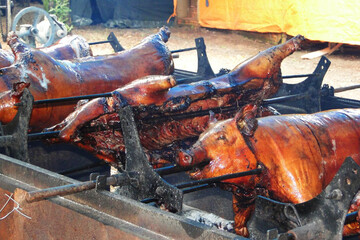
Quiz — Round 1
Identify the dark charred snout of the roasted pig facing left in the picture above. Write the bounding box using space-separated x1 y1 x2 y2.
177 147 207 167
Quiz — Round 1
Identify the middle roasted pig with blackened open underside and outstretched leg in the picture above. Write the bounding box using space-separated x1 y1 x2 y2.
47 36 303 165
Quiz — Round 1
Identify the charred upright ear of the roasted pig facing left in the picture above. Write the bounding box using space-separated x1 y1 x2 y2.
235 104 258 137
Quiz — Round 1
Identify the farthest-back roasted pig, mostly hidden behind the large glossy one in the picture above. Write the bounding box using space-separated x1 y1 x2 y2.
0 32 92 68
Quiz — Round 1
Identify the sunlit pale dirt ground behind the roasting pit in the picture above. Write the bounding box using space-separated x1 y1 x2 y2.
2 10 360 100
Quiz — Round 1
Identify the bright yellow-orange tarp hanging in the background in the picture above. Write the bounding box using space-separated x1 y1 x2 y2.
198 0 360 45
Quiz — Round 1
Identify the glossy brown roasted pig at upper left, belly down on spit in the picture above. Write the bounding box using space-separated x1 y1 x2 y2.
0 28 174 130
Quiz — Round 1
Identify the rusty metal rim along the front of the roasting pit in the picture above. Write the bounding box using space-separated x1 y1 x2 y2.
0 154 246 239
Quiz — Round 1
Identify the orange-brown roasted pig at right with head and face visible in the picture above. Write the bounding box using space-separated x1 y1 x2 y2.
178 106 360 235
